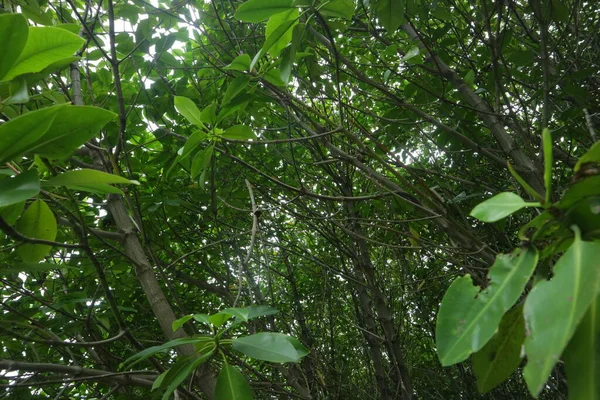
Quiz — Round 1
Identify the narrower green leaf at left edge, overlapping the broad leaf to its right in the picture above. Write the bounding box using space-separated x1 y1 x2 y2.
0 105 68 163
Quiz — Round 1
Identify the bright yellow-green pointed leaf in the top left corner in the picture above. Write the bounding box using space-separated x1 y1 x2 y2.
2 26 85 81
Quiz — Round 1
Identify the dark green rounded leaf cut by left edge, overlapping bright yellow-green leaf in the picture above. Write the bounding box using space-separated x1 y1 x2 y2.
0 14 28 81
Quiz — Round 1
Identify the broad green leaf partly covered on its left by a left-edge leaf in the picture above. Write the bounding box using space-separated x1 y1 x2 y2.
26 105 117 159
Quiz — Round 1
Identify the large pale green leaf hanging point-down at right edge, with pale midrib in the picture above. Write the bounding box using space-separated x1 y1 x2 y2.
523 228 600 396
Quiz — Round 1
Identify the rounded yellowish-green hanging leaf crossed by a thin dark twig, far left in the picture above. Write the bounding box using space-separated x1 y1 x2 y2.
17 200 57 263
